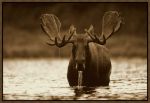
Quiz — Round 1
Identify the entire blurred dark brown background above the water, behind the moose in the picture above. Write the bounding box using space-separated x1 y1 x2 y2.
3 3 147 57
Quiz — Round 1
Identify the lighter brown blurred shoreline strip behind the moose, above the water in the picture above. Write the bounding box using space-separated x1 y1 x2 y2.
3 27 147 58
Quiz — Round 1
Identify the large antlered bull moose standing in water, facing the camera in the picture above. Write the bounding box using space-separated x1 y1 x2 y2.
41 11 122 87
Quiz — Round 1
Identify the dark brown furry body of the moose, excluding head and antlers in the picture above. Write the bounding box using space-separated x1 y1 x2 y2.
67 43 111 86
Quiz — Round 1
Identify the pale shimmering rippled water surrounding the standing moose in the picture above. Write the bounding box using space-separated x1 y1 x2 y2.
3 58 147 100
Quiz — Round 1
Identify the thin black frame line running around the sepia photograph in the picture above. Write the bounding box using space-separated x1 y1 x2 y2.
1 1 149 101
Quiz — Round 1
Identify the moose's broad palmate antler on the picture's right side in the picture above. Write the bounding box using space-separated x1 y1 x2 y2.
85 11 122 45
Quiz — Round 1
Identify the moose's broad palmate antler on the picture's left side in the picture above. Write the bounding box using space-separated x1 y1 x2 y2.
41 14 76 47
